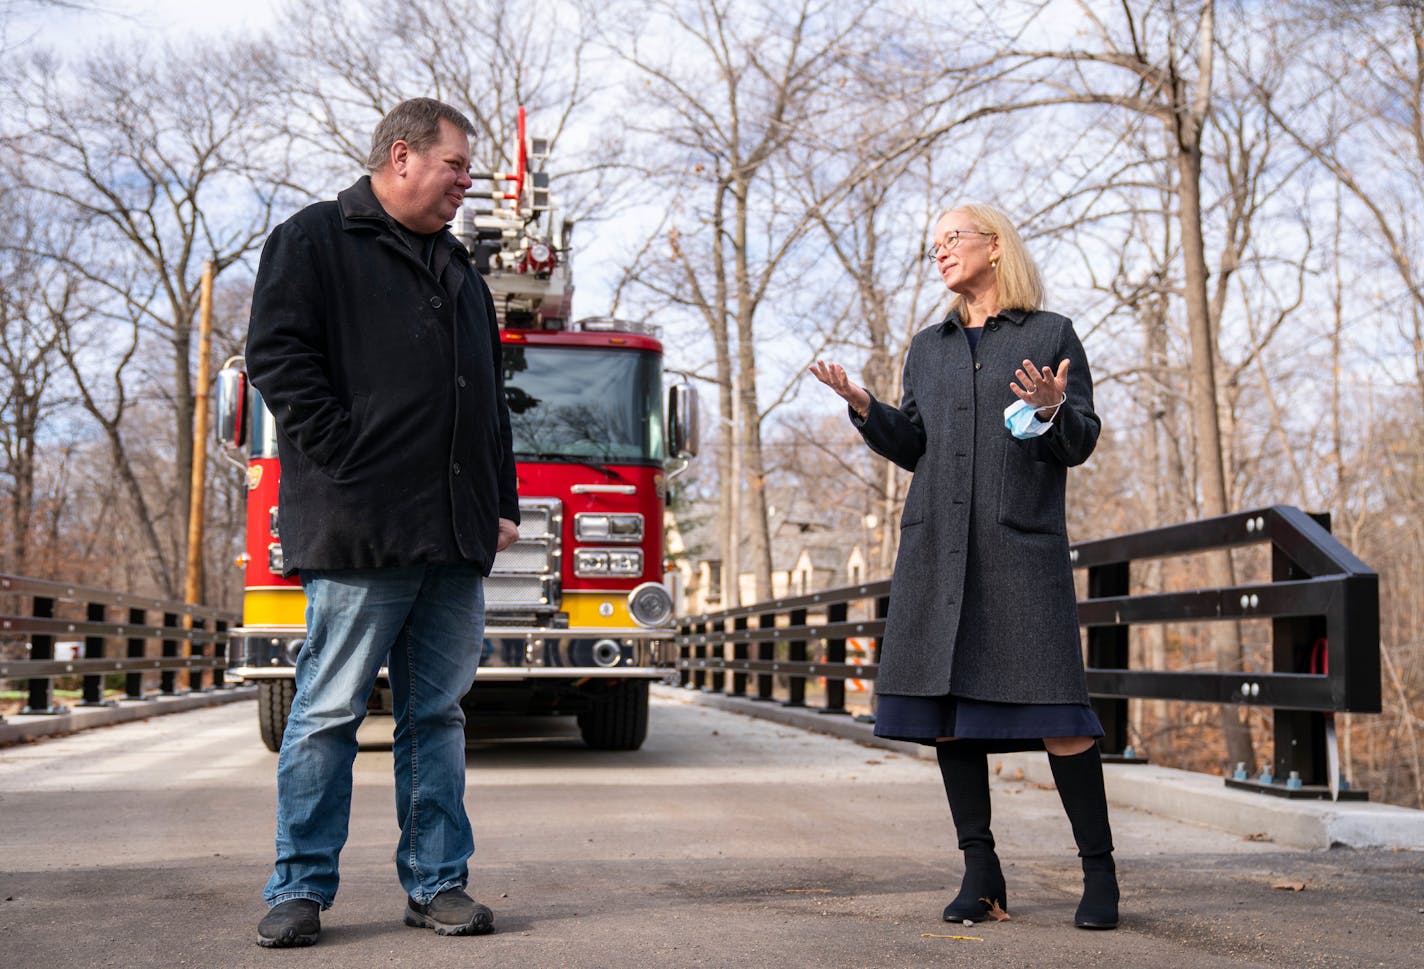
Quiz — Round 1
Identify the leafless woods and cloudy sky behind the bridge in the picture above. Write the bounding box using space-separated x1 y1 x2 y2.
0 0 1424 807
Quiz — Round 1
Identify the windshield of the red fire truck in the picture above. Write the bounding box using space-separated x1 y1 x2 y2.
504 343 664 463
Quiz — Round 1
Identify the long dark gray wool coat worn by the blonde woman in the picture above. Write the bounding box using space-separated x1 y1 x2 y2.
852 309 1101 704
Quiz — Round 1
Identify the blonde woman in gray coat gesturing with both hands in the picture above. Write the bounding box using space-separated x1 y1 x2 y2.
812 205 1118 929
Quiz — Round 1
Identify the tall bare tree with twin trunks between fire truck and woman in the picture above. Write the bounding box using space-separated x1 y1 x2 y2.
608 0 899 597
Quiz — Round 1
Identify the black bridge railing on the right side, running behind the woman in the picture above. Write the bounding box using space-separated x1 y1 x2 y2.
678 504 1380 797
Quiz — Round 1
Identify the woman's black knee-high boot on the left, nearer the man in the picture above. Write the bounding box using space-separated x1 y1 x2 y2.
936 741 1008 922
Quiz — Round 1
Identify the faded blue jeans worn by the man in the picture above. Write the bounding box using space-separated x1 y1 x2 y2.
262 566 484 909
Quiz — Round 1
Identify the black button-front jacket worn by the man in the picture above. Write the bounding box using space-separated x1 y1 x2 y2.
246 178 518 574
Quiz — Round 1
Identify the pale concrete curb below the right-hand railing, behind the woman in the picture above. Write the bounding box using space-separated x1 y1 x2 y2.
655 687 1424 851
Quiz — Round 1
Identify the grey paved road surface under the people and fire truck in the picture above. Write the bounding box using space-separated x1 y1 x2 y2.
0 695 1424 969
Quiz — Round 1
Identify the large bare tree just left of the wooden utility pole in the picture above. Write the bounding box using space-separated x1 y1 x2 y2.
4 44 290 594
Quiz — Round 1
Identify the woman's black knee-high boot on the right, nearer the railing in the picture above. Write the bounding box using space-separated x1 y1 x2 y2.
1048 744 1118 929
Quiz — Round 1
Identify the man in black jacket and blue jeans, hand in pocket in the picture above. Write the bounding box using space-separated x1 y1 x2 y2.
246 98 518 946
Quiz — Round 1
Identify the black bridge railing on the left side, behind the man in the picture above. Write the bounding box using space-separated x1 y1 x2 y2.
0 574 238 720
